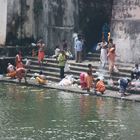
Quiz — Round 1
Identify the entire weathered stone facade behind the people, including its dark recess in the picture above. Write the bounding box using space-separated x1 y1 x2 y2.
0 0 140 62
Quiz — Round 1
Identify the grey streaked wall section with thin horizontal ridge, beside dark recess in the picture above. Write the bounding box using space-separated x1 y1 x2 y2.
40 0 78 53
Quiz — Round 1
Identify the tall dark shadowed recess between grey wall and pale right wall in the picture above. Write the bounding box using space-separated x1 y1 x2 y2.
79 0 113 51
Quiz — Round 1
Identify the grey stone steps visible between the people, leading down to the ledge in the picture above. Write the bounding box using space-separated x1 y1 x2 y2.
24 53 140 93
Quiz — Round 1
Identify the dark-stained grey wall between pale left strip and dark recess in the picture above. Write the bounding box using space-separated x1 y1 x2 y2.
7 0 78 52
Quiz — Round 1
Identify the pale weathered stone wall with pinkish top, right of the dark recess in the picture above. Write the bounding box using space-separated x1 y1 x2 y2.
111 0 140 63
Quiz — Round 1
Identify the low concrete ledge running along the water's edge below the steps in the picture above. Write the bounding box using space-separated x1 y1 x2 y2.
0 78 140 102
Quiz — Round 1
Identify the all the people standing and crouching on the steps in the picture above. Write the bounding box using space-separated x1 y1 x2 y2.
4 35 140 96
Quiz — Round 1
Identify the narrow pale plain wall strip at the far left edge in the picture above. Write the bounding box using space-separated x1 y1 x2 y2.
0 0 7 45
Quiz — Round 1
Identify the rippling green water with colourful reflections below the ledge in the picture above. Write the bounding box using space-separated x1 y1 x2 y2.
0 83 140 140
